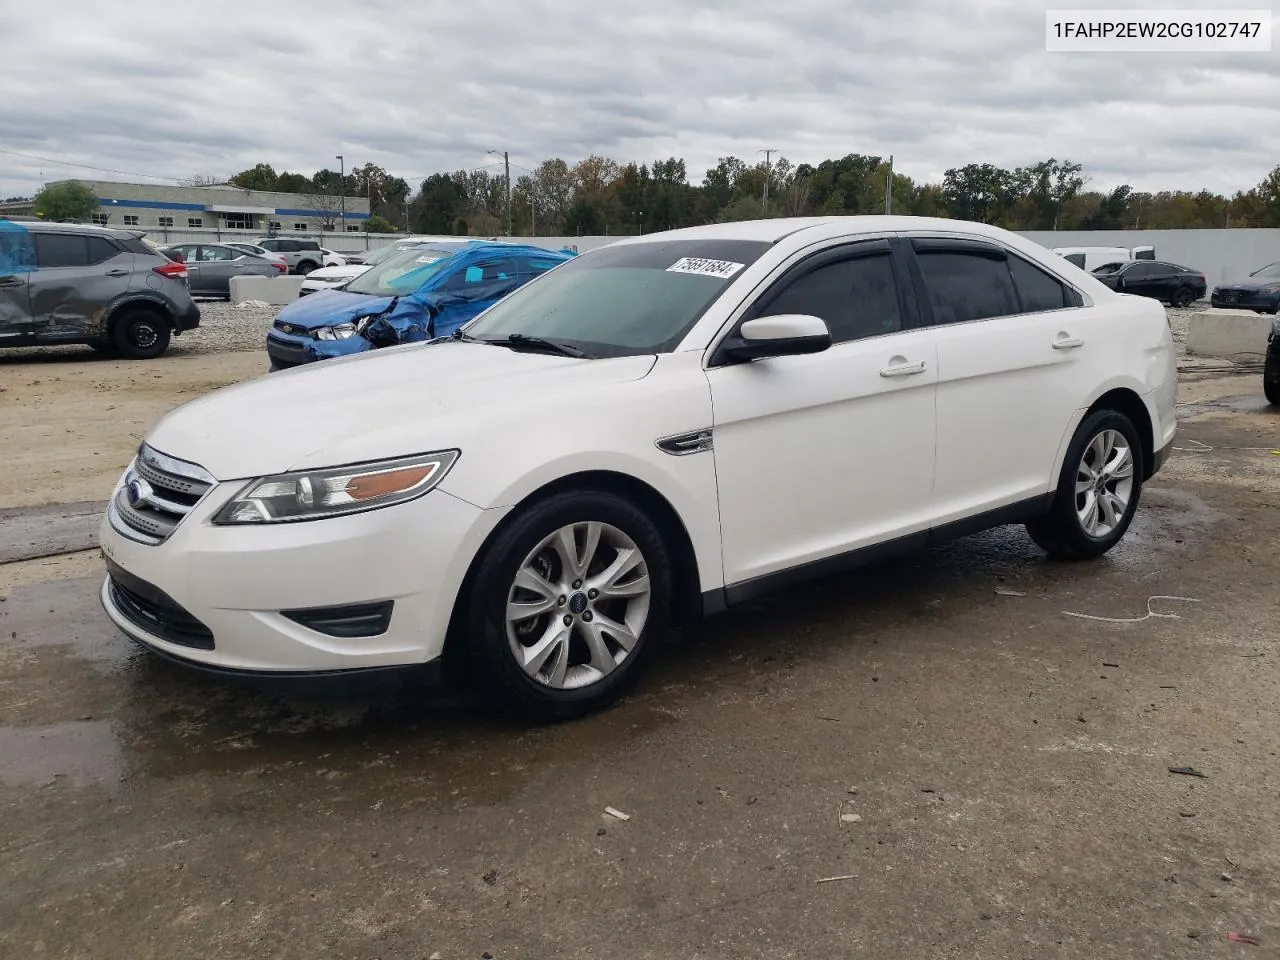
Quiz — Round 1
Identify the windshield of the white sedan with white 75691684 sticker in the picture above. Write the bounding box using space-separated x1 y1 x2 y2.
466 239 769 357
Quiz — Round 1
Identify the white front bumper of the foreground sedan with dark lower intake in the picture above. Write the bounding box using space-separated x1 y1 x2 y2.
99 481 504 676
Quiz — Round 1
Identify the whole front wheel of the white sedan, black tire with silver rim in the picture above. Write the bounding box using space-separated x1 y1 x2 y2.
458 490 672 722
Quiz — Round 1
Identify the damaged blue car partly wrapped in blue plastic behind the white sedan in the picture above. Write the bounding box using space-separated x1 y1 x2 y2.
266 241 573 370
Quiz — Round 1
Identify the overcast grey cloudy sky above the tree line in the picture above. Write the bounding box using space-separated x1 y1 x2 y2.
0 0 1280 197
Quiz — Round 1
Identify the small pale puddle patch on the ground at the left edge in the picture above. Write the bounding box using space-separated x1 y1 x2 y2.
0 721 120 787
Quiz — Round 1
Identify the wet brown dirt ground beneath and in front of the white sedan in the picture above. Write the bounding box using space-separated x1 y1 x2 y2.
0 371 1280 960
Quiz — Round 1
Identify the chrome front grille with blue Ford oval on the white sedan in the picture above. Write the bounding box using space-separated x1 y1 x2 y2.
108 444 218 544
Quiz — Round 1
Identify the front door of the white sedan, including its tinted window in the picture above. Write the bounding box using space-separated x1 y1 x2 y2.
707 239 937 586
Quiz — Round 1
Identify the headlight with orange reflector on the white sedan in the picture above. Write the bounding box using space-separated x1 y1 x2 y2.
214 451 461 525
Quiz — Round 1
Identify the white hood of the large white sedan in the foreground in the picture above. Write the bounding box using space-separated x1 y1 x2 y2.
147 340 655 480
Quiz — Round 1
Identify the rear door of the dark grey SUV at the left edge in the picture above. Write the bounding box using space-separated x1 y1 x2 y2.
31 233 133 339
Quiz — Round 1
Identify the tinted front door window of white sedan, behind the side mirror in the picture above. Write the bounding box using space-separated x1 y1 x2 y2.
754 253 902 343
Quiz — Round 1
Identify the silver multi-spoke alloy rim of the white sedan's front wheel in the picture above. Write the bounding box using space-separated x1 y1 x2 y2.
506 521 653 690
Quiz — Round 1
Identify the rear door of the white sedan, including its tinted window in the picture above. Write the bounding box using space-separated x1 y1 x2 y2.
911 237 1106 526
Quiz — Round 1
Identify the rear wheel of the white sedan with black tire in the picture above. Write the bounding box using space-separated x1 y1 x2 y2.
1027 410 1146 561
